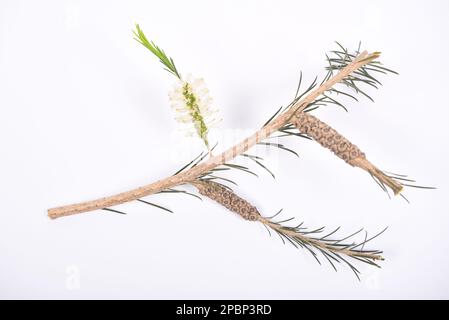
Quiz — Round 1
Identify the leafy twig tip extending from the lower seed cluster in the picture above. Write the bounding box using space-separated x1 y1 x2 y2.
260 210 387 280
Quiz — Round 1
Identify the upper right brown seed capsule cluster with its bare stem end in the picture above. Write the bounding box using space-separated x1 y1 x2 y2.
291 112 403 195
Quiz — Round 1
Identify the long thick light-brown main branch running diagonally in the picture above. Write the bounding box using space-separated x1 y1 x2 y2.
48 51 379 219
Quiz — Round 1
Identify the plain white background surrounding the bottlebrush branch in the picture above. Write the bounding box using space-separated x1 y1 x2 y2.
0 0 449 299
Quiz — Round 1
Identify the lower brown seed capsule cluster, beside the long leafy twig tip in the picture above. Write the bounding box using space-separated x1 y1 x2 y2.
193 181 260 221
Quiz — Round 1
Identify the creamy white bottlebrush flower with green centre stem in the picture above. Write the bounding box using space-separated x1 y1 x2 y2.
169 76 219 149
